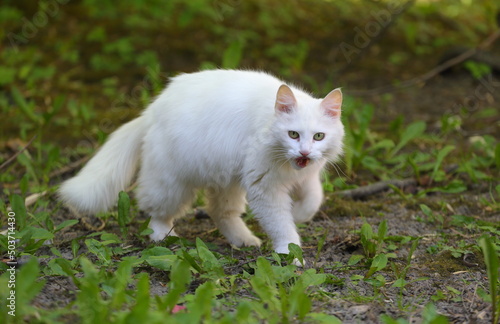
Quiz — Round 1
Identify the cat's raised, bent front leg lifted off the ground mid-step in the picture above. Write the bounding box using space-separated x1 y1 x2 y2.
292 177 323 223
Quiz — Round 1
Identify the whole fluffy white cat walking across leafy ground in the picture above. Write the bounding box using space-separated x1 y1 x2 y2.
60 70 344 253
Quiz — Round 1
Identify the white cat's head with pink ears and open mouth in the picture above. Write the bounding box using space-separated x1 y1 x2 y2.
273 85 344 170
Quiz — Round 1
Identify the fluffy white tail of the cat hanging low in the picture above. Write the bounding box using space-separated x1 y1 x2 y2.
59 116 146 214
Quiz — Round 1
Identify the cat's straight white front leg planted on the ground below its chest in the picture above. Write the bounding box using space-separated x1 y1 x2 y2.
248 189 300 254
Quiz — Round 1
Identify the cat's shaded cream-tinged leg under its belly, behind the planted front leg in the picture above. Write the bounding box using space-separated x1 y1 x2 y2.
206 184 261 247
